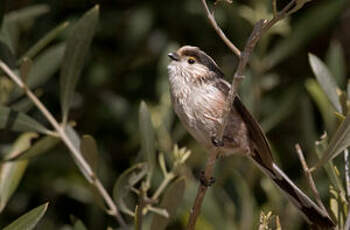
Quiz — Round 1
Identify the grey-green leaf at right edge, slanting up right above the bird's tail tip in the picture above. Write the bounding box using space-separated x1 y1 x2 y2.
313 115 350 169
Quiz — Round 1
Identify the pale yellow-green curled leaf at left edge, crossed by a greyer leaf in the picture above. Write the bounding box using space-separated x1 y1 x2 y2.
0 133 38 212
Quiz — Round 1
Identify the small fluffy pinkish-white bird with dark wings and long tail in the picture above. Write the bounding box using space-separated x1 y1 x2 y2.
168 45 335 229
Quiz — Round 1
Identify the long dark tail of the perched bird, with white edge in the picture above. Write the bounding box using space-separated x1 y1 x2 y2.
252 154 335 229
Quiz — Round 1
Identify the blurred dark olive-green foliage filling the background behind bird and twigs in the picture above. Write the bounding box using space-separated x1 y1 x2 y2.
0 0 350 230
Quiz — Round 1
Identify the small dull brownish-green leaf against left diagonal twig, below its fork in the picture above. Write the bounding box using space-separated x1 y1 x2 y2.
80 135 99 173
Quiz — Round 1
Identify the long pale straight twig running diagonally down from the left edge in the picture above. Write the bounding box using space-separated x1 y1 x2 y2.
0 60 126 226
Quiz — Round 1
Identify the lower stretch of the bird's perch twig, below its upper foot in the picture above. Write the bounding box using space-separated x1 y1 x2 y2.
186 149 219 230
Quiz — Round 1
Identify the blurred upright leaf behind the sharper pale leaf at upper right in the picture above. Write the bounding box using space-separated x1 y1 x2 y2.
326 40 346 86
